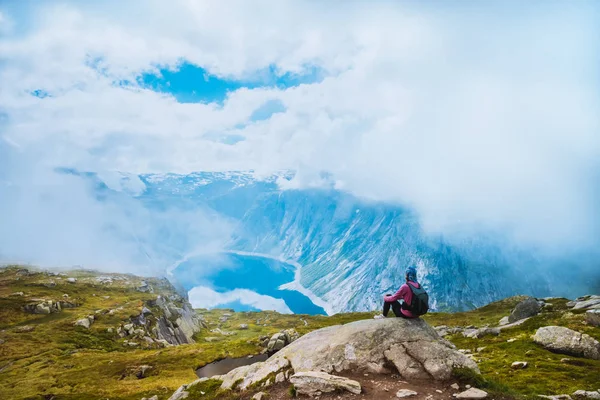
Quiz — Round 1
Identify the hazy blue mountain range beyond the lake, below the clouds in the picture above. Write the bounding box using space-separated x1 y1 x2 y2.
55 171 595 312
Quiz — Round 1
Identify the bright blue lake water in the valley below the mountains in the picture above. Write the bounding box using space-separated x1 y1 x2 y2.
173 254 325 315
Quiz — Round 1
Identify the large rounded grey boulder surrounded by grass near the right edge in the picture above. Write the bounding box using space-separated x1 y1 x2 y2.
533 326 600 360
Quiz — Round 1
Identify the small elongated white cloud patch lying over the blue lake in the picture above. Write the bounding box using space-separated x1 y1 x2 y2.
188 286 292 314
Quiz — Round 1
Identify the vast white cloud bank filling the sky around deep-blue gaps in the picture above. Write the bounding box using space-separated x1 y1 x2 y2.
0 0 600 266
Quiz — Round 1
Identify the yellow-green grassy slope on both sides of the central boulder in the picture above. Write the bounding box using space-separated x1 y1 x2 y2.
0 269 600 400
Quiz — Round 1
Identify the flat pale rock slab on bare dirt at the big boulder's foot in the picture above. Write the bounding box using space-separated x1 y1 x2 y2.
290 371 362 396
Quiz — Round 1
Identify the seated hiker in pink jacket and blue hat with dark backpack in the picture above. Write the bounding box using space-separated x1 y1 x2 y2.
375 267 429 319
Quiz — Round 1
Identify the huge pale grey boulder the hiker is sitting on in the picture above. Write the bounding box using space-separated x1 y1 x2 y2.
204 318 479 390
